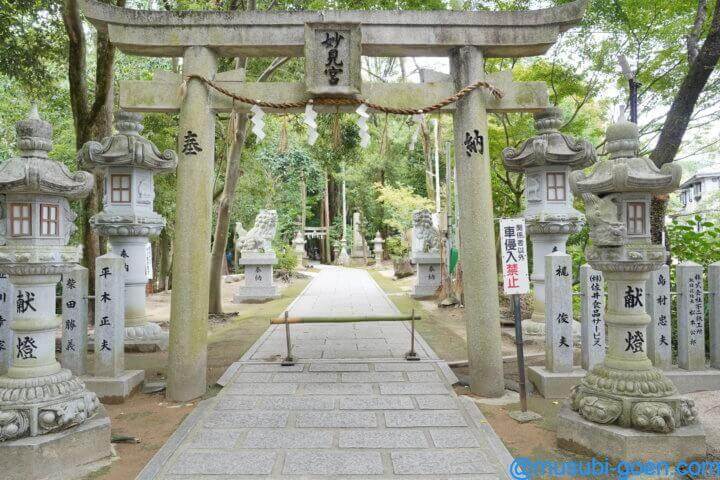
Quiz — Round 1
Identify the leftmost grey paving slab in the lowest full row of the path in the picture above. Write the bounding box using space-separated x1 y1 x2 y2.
168 450 277 475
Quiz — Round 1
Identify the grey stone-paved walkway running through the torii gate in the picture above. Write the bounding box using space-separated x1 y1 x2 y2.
138 268 512 479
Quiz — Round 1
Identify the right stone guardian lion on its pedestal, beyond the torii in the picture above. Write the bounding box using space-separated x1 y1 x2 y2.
411 209 442 298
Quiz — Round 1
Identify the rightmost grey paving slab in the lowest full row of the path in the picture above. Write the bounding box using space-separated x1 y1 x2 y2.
390 450 496 475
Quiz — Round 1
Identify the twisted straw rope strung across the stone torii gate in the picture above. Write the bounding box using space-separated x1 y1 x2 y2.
181 74 505 115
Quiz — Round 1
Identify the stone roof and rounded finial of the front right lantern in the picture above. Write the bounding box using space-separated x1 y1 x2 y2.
570 120 682 195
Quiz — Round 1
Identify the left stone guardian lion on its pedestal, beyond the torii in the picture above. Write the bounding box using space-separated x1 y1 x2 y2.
233 210 280 303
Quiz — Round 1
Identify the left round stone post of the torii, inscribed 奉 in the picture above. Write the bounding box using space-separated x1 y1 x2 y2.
167 47 217 401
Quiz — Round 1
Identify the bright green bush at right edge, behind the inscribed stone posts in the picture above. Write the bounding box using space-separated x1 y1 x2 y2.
667 215 720 265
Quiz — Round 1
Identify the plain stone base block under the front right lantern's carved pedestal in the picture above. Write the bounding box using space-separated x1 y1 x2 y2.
557 402 706 464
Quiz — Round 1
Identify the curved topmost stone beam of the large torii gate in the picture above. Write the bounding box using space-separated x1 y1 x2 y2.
80 0 589 57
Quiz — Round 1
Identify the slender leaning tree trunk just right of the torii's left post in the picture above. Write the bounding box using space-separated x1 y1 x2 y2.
209 113 248 314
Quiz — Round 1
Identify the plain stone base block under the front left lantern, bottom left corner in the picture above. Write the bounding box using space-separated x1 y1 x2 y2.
0 406 112 480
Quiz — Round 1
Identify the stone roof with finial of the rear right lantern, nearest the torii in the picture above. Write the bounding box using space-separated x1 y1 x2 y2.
502 107 597 172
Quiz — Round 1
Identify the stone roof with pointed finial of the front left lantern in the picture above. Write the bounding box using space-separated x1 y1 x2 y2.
0 107 94 199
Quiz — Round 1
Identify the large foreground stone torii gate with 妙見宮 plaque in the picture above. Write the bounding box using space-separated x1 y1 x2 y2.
81 0 587 401
